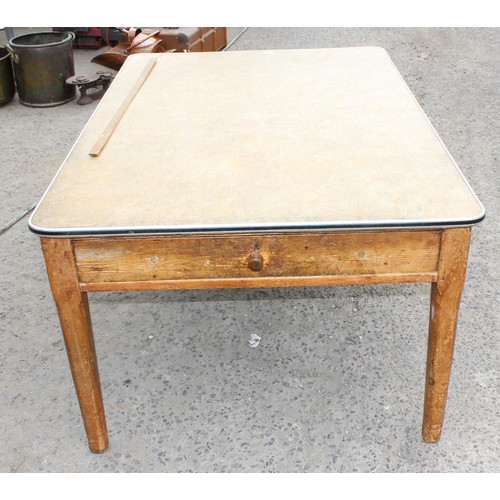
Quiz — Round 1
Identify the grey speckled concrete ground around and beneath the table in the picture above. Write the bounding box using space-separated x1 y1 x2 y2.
0 28 500 472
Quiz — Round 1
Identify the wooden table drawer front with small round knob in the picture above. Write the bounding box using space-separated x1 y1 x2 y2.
73 230 441 284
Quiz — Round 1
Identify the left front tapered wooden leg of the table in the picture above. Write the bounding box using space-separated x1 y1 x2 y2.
41 238 108 453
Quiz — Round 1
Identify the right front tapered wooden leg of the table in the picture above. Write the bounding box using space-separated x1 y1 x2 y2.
422 228 471 443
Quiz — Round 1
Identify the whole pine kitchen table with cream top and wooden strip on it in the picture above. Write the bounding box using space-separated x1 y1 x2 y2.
29 47 485 453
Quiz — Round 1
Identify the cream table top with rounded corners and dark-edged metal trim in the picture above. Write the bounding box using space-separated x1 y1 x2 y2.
30 47 484 236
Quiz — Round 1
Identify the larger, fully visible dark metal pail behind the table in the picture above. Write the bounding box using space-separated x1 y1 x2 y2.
9 31 76 107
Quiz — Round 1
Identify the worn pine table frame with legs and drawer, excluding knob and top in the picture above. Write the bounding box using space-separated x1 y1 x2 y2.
41 227 471 453
